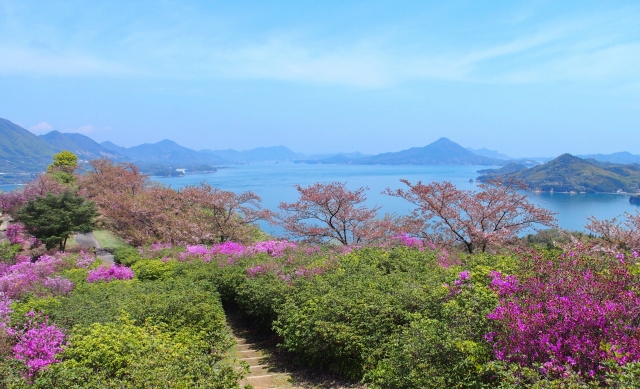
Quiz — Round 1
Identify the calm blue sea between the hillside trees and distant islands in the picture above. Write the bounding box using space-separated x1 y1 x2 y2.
0 163 640 233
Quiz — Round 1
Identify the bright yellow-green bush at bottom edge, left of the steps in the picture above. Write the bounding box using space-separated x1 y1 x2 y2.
0 319 247 389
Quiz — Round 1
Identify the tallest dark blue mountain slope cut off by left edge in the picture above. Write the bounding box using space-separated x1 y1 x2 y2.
0 119 56 173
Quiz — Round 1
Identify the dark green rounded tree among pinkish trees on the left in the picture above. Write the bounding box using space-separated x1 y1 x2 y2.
17 191 97 251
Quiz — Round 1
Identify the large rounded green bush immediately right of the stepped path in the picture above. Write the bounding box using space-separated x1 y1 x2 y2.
274 248 446 378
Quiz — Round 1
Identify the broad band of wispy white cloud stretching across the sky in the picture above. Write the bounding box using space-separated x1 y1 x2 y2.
0 2 640 88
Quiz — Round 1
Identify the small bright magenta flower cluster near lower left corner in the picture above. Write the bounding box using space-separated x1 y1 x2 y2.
7 311 65 377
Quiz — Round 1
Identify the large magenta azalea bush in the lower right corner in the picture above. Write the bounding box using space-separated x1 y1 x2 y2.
485 253 640 376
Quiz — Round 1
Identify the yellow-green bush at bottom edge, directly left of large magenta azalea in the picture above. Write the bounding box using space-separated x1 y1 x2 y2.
365 268 497 389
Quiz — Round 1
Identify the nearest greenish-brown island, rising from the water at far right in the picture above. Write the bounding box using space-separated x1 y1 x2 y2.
478 154 640 193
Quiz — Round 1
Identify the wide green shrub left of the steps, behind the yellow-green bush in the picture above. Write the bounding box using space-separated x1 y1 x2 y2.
44 279 232 351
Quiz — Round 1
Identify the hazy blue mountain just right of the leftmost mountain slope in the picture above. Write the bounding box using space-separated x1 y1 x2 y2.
39 131 125 160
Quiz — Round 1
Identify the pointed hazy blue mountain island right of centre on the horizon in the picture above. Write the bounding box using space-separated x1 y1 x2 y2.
352 138 506 165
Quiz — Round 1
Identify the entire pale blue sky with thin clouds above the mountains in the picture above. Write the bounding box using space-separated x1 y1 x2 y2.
0 0 640 157
